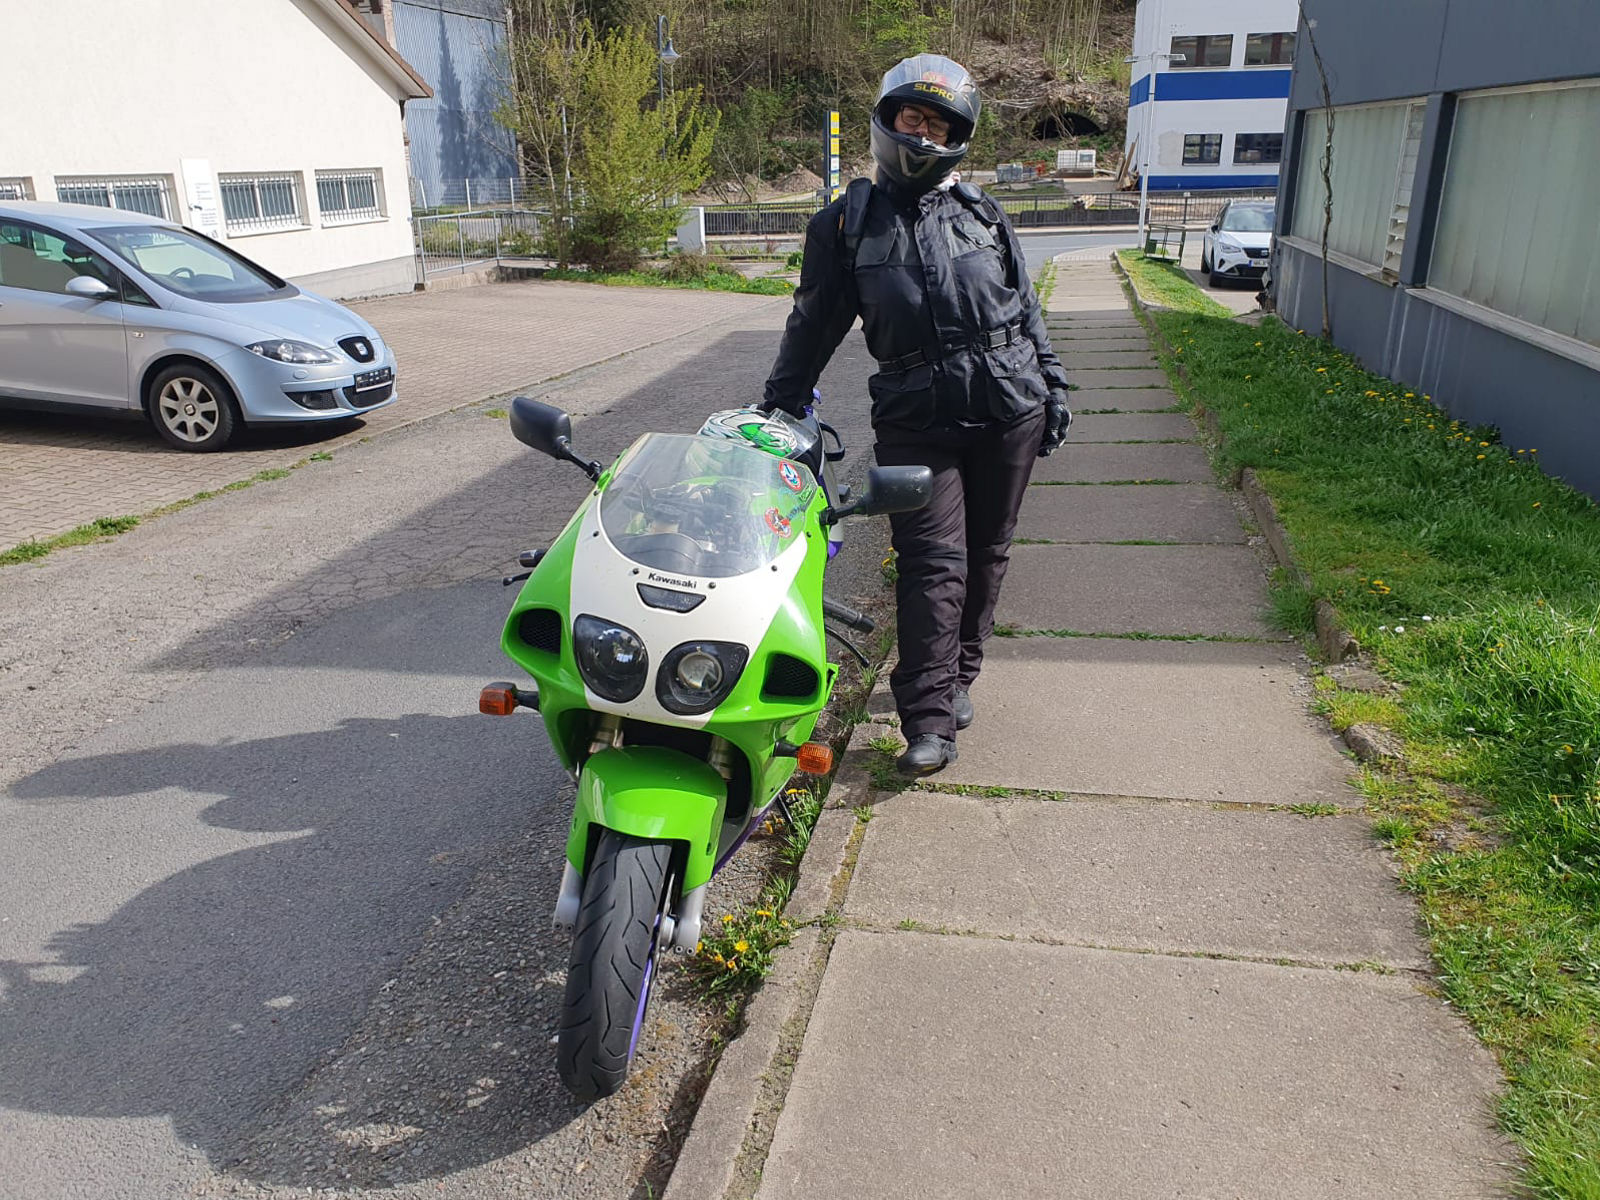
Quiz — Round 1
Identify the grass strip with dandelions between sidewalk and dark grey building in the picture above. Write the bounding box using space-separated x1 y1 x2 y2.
1145 256 1600 1197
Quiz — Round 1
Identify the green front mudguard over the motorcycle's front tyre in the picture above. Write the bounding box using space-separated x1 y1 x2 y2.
566 746 728 890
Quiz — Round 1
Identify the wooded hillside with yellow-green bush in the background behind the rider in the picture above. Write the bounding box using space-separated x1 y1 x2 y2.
501 0 1134 269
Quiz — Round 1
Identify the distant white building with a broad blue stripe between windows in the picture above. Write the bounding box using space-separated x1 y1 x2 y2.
1126 0 1299 189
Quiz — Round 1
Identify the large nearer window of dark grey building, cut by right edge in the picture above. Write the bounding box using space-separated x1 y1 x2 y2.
1427 80 1600 346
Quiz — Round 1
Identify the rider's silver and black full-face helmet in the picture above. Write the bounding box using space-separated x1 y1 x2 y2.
872 54 979 192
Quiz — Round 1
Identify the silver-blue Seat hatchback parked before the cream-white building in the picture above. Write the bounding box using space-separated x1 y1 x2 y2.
0 200 395 450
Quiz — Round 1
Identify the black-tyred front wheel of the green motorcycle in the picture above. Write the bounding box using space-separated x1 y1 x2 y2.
555 830 672 1104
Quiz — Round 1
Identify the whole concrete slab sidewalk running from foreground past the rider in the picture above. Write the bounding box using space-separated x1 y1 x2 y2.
667 261 1515 1200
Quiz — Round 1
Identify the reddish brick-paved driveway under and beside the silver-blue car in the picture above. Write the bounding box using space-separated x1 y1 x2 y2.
0 282 789 549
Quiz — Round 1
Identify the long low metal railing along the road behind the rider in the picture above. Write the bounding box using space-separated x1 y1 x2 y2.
706 190 1277 237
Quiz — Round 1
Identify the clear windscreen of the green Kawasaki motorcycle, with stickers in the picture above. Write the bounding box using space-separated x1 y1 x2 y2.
600 434 816 579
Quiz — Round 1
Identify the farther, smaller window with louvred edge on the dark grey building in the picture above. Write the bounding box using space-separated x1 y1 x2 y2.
1290 101 1421 269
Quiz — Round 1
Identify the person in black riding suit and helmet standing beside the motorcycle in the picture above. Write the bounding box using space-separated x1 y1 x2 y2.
762 54 1072 774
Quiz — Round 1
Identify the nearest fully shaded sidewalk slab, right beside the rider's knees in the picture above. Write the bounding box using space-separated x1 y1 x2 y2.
995 546 1283 638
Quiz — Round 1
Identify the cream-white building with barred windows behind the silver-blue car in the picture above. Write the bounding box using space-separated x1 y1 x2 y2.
0 0 430 298
